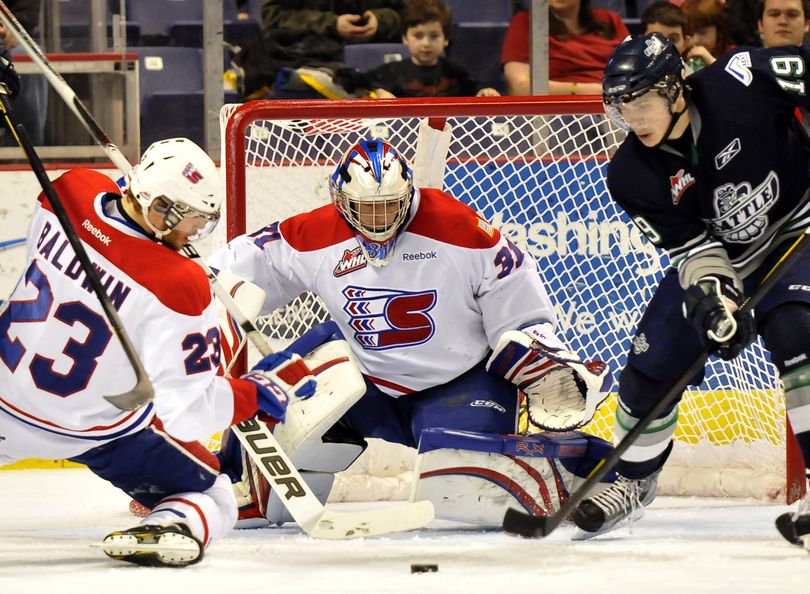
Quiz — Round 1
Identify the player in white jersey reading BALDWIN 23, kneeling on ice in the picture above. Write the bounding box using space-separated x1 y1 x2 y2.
0 138 314 566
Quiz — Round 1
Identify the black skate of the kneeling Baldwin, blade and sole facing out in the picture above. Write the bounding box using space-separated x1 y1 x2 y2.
100 524 204 567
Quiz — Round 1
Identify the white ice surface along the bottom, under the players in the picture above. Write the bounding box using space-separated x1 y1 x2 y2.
0 469 810 594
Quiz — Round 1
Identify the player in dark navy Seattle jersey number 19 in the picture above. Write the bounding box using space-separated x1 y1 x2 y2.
574 33 810 540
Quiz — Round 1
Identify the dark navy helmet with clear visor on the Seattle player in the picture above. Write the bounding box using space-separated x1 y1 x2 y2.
602 33 685 142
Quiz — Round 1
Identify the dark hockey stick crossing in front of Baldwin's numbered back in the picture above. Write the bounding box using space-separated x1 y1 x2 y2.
0 90 155 410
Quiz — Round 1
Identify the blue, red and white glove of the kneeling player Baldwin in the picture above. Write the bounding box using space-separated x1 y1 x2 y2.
242 351 315 422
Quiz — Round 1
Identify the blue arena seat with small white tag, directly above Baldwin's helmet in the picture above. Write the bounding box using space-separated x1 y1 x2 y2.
129 46 205 147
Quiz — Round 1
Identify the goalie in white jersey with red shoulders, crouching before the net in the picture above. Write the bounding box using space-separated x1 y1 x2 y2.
210 140 609 526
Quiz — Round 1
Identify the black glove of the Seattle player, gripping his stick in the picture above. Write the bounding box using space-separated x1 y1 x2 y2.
684 276 757 361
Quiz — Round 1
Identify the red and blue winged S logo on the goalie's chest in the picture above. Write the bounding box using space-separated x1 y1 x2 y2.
343 286 437 351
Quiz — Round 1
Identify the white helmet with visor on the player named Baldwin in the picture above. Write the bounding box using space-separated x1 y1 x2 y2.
127 138 224 241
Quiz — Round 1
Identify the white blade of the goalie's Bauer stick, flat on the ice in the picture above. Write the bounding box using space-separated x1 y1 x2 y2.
307 501 435 540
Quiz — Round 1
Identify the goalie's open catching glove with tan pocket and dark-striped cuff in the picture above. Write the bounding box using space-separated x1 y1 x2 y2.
487 324 612 431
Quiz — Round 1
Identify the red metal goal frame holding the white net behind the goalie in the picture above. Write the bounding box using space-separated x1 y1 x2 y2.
222 96 806 503
